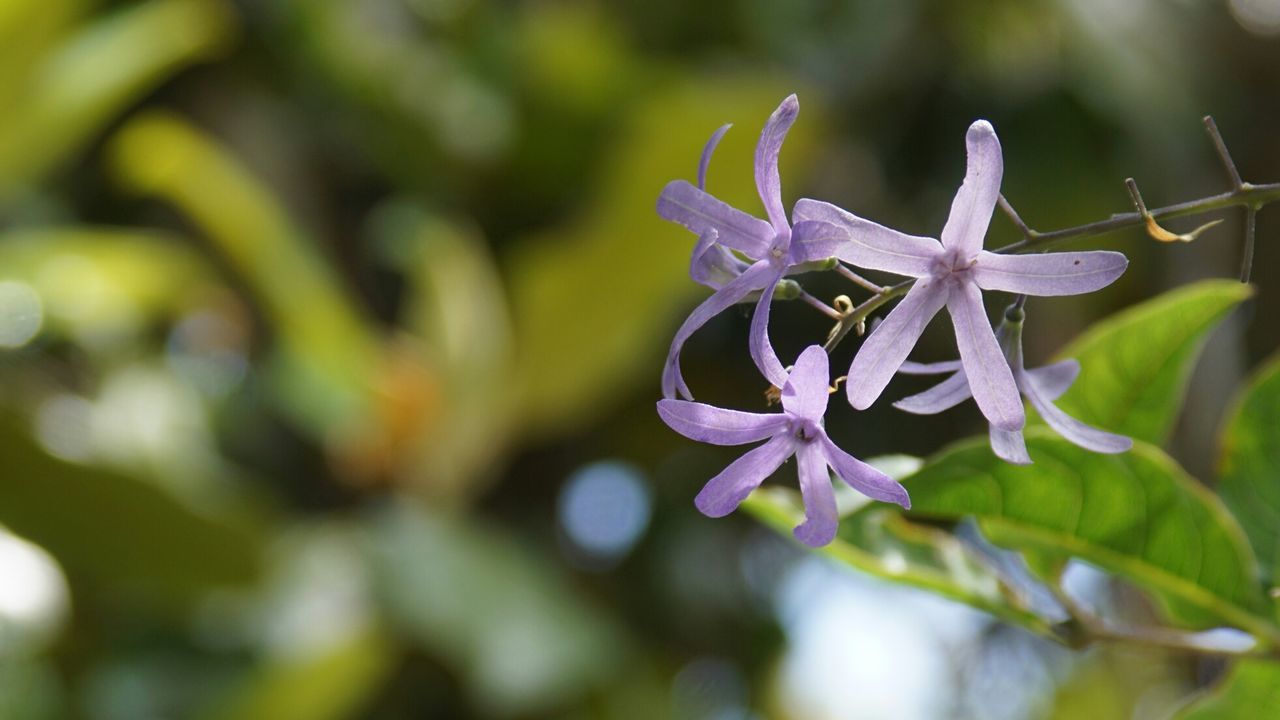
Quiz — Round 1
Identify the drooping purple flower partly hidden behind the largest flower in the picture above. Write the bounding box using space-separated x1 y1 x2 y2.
893 307 1133 465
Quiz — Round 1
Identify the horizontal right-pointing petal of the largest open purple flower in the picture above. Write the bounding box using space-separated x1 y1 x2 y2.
973 250 1129 296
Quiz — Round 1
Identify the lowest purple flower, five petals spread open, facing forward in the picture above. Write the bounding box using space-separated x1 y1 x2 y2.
658 345 911 547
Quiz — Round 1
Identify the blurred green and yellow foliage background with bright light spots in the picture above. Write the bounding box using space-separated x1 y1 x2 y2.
0 0 1280 720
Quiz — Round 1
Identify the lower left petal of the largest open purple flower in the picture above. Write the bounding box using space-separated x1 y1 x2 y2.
846 279 947 410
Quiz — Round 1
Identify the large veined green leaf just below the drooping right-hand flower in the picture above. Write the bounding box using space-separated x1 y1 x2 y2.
904 429 1280 642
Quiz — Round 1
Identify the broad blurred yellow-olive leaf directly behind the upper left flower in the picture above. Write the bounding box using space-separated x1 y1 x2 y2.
506 78 820 432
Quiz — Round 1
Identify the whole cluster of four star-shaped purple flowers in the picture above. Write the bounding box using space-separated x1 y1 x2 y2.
658 95 1132 547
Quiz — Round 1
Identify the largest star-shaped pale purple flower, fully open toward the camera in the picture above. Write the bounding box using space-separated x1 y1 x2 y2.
795 120 1128 430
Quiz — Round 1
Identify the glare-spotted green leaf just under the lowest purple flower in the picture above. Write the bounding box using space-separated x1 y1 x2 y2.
742 487 1050 634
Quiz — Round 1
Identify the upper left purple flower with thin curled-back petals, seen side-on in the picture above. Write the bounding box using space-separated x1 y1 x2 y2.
658 95 849 398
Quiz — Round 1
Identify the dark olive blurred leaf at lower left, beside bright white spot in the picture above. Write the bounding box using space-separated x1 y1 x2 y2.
0 412 261 607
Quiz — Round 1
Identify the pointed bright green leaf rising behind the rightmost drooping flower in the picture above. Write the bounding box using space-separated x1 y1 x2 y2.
1057 281 1253 445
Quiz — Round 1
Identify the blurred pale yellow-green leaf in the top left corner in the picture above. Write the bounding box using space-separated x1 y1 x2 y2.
0 0 232 197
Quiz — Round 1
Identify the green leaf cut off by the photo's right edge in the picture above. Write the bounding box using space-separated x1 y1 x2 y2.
1217 356 1280 583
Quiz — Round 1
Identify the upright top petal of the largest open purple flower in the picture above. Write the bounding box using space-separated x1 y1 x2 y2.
942 120 1005 259
